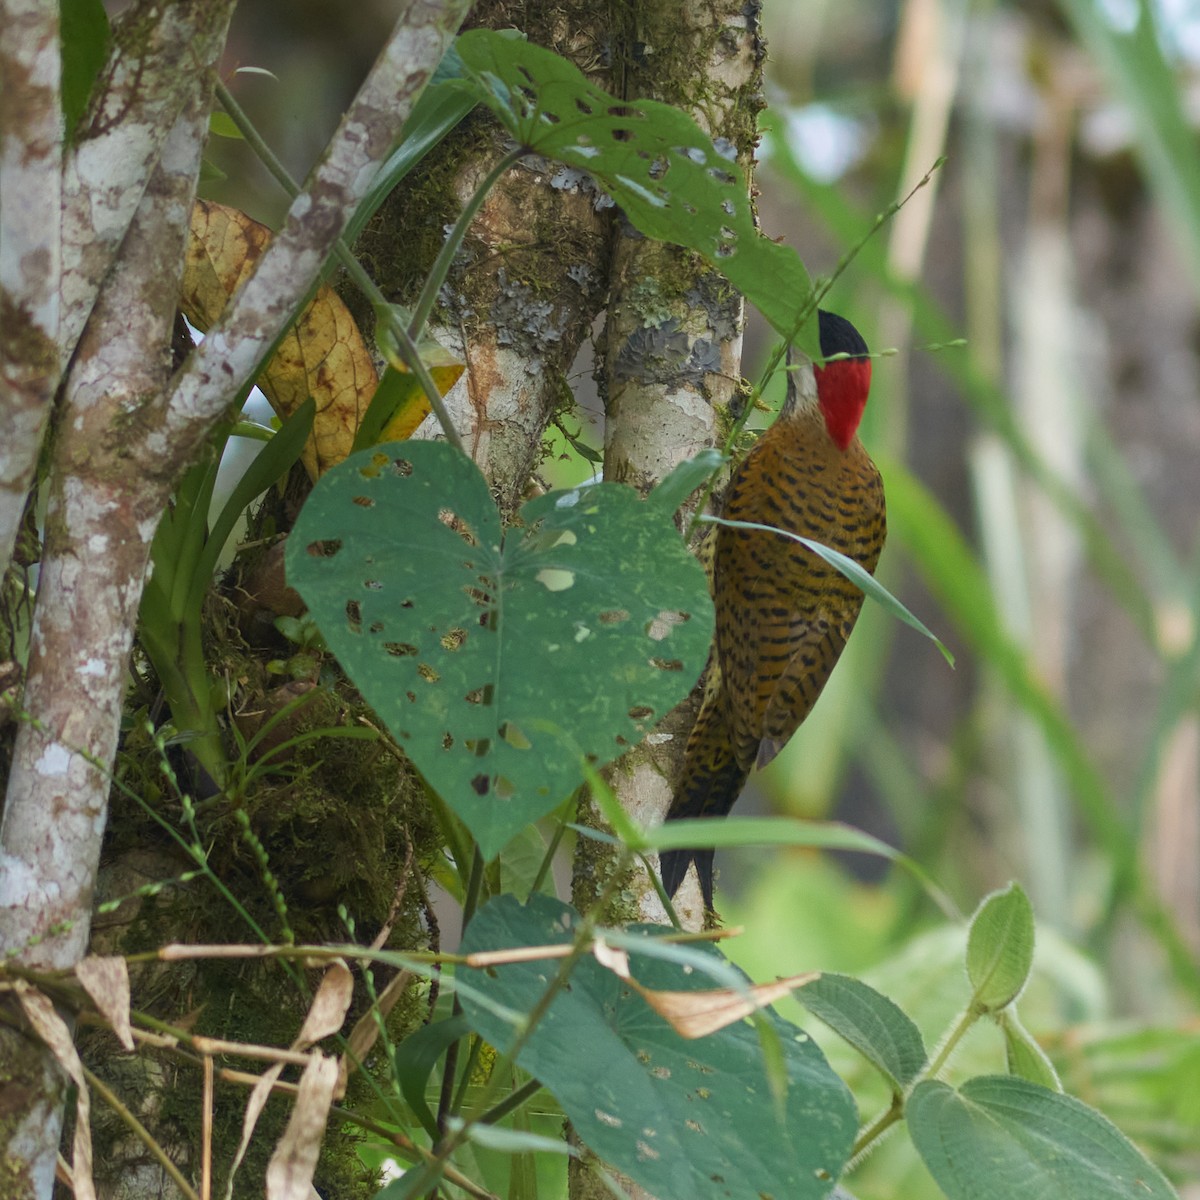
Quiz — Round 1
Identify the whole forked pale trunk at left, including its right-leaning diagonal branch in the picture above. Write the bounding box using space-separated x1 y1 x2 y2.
0 0 467 1200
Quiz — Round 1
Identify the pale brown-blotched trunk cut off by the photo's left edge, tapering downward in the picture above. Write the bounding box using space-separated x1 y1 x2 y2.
0 0 62 571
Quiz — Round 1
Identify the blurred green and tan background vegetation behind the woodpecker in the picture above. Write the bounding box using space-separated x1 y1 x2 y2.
199 0 1200 1198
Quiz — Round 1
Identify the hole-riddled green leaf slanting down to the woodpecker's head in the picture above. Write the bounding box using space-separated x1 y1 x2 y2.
457 29 821 350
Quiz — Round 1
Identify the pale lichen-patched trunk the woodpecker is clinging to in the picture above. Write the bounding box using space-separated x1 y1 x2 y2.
583 0 764 929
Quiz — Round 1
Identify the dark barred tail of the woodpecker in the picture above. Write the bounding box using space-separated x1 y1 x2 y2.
659 703 749 908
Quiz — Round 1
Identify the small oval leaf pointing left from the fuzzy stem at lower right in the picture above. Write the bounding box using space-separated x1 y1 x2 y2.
797 973 929 1092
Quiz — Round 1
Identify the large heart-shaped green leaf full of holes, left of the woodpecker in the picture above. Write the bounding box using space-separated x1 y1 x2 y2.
287 442 713 859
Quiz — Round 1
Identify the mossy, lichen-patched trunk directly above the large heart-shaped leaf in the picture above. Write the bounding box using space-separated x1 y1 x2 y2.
358 0 612 517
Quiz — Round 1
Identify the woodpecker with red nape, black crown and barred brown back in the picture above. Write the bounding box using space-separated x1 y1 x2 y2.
660 311 887 908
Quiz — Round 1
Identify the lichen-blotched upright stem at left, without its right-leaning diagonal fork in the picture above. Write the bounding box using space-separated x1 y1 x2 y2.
0 18 233 1196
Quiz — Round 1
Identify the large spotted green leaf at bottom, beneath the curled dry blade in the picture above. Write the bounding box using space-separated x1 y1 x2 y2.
460 896 856 1200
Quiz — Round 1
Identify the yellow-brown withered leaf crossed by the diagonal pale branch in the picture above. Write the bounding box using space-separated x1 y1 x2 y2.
180 200 379 479
